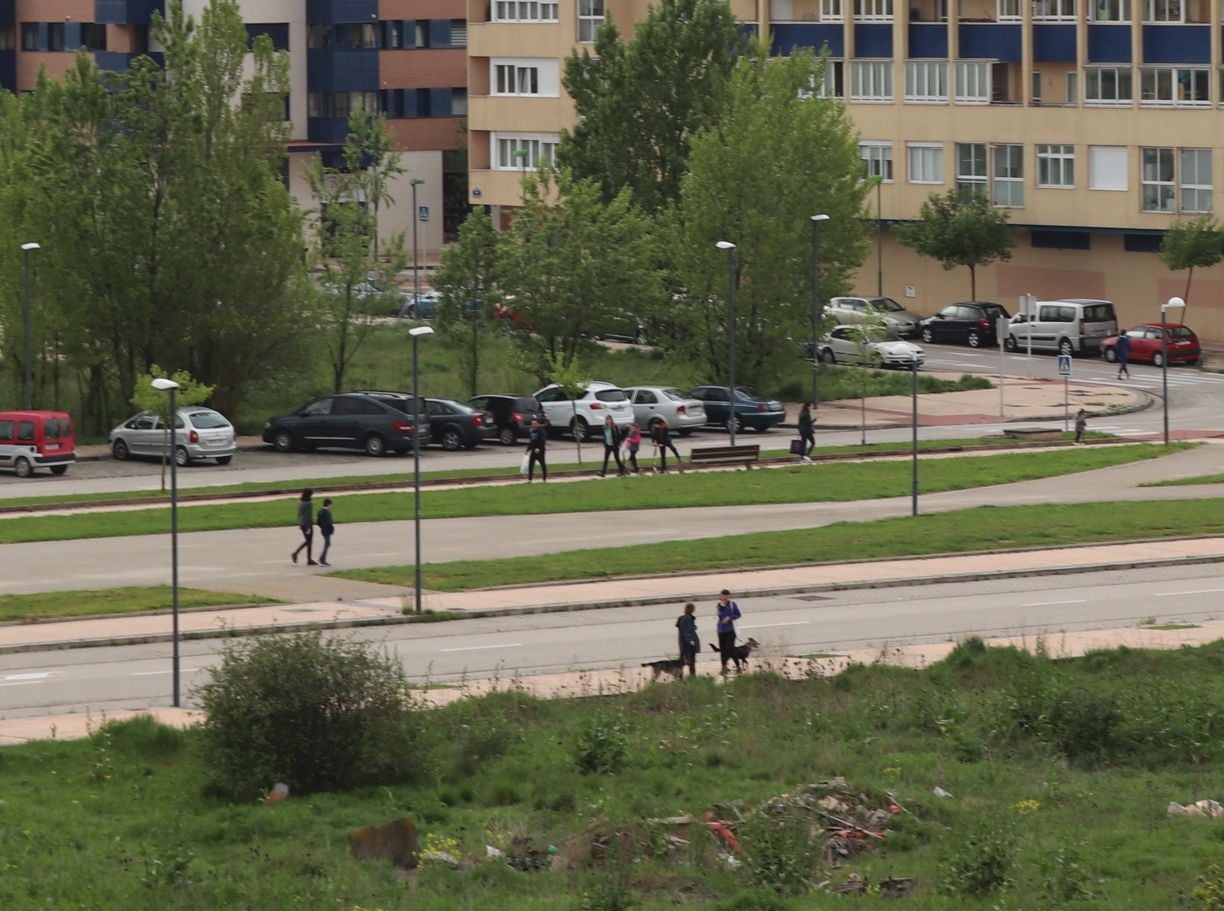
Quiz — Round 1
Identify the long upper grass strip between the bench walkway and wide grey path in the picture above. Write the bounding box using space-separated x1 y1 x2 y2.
0 446 1176 544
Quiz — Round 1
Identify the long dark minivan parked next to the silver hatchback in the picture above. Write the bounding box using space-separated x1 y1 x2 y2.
263 392 430 456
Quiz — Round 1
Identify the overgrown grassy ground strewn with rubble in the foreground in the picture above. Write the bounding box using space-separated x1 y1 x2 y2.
0 642 1224 911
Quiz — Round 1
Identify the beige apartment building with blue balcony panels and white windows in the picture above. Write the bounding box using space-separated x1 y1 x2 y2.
468 0 1224 339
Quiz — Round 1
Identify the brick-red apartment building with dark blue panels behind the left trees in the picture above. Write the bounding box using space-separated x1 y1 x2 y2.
0 0 468 255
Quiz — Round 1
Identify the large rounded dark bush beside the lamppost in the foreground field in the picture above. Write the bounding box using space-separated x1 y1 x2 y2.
201 632 422 797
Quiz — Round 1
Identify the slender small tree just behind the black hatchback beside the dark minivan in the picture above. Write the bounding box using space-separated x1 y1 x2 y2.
433 212 499 396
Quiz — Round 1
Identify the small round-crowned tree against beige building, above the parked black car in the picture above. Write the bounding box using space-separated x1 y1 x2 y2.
894 190 1016 300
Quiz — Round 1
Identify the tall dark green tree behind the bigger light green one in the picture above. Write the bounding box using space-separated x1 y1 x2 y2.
558 0 744 213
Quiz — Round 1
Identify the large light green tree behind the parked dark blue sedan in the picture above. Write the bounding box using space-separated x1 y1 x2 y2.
661 49 868 384
